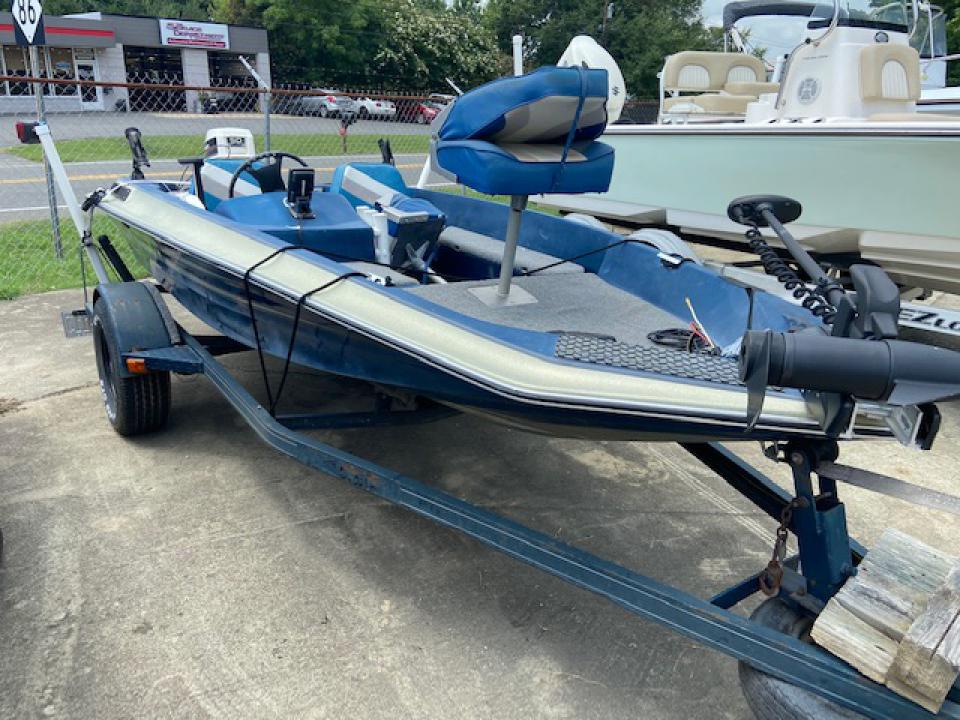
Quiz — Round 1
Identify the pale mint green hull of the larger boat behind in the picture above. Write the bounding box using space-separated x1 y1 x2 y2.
546 123 960 292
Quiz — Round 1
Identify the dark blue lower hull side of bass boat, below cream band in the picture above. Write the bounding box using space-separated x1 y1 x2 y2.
114 221 818 441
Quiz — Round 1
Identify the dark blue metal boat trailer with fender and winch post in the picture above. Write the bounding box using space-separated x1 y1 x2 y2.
87 282 960 720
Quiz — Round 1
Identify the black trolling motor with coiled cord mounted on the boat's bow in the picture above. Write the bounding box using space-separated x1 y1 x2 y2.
727 195 960 448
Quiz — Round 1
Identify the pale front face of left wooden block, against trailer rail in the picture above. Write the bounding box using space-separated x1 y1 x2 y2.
810 598 898 683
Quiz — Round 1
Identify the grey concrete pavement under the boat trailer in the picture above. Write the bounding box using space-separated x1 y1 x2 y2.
0 291 960 720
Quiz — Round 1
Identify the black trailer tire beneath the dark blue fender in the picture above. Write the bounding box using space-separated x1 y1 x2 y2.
93 298 170 437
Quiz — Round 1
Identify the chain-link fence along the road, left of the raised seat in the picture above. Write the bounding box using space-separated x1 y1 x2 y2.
0 75 436 298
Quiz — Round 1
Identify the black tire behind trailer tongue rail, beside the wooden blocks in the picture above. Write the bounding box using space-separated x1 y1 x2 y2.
738 598 864 720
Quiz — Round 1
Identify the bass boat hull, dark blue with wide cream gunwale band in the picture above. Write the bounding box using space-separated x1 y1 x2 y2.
90 184 889 441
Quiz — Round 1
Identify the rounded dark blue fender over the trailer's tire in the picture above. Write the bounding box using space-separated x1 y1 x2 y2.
93 282 180 377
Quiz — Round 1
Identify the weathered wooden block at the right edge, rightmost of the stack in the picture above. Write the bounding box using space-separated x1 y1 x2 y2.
887 566 960 713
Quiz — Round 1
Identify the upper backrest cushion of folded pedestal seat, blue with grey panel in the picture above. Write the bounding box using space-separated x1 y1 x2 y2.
438 67 607 143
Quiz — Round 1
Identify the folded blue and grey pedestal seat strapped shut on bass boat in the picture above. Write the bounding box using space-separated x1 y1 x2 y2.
435 67 613 196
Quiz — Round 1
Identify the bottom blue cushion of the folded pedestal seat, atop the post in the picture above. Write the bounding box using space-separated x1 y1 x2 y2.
437 140 613 195
